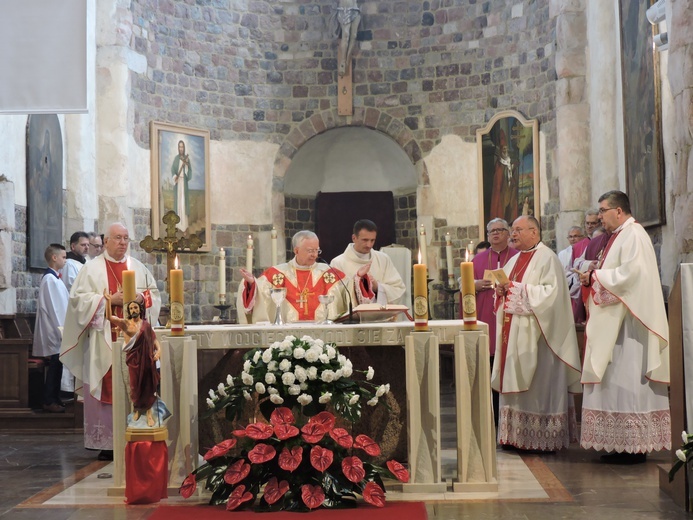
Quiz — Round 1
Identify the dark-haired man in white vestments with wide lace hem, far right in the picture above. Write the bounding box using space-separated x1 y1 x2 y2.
580 191 671 464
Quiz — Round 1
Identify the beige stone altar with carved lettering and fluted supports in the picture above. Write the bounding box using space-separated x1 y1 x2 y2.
110 320 497 495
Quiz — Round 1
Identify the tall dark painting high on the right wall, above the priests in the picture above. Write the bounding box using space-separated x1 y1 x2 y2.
619 0 666 227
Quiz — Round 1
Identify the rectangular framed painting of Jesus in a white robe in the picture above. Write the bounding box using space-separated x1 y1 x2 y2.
150 121 211 251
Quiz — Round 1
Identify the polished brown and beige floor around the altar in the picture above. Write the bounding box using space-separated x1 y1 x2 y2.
0 433 691 520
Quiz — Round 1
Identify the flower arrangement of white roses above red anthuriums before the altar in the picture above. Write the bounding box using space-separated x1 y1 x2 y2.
180 336 409 511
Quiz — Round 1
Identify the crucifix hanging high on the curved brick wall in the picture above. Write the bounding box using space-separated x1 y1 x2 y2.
334 0 361 116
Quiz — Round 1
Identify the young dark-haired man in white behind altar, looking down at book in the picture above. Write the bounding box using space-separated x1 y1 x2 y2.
331 219 407 305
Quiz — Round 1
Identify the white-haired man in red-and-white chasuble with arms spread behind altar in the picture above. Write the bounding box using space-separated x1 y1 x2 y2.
236 231 348 323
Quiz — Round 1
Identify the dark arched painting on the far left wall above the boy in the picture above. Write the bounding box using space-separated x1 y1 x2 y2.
26 114 65 269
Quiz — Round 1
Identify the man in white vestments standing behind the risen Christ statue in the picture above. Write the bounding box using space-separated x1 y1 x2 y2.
60 223 161 460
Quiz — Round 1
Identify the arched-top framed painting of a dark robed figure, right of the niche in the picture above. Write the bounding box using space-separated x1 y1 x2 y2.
476 110 539 237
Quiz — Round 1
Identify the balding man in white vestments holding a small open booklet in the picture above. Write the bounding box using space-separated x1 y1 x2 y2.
491 216 580 451
